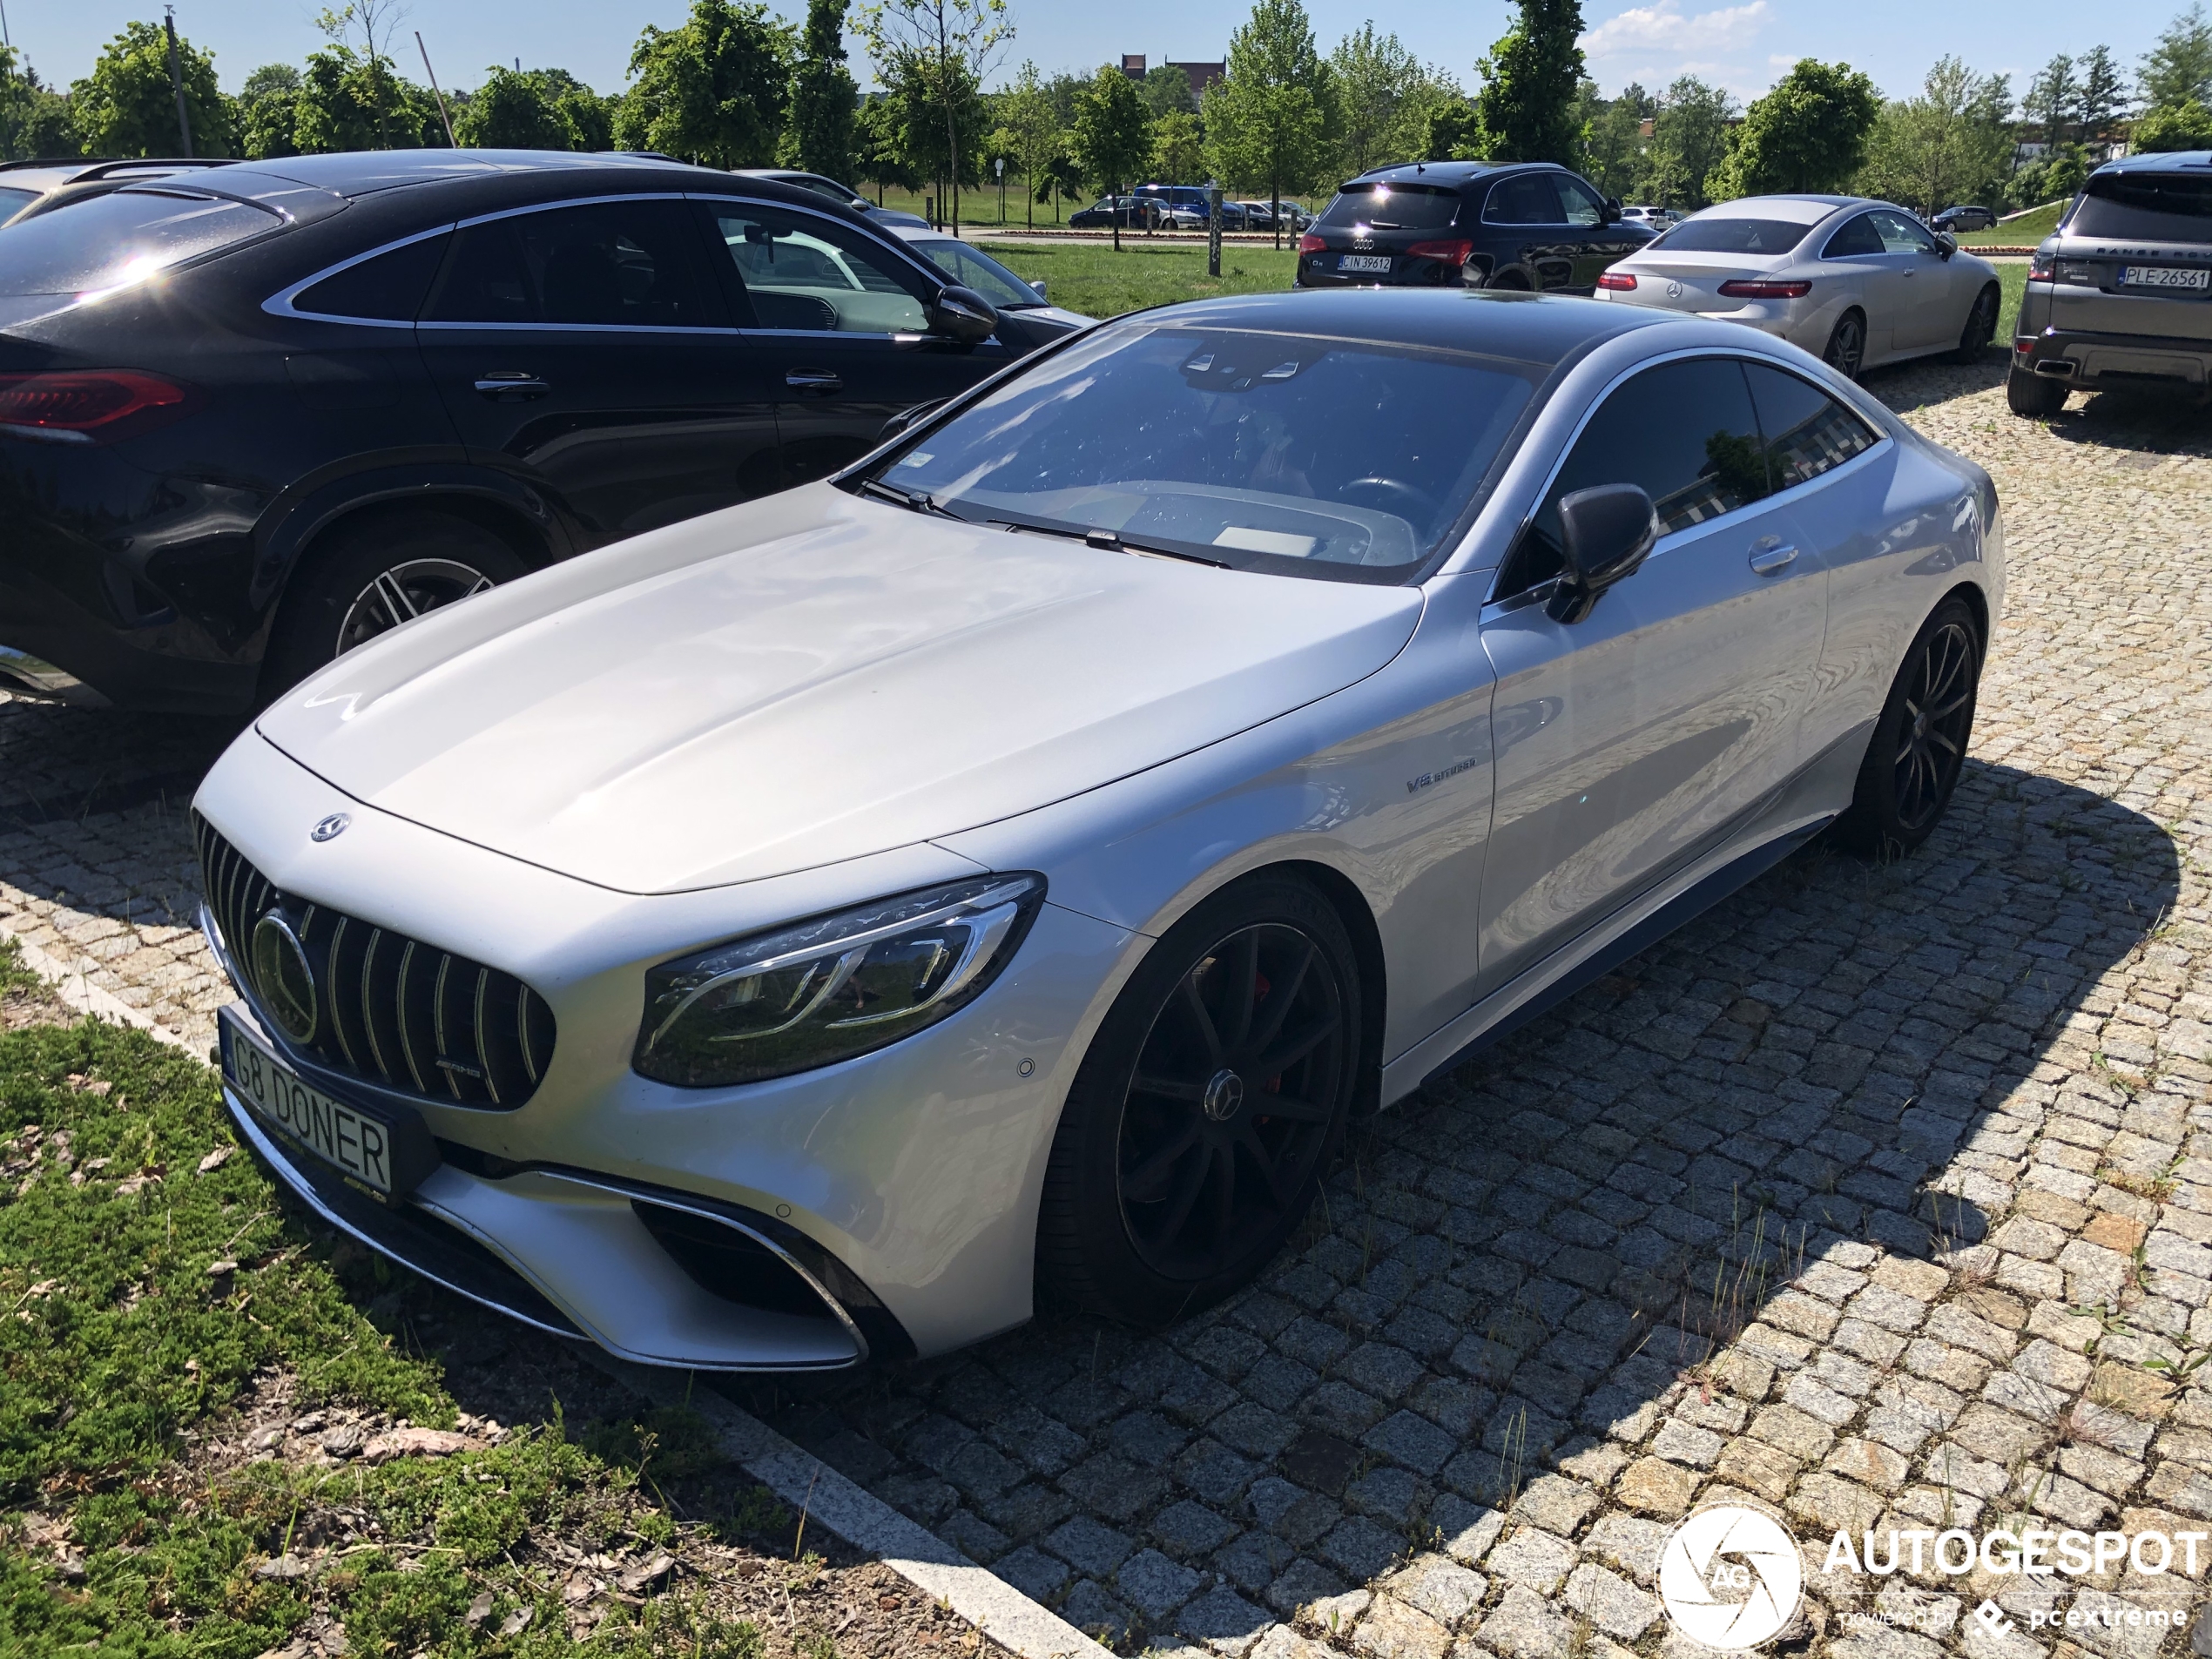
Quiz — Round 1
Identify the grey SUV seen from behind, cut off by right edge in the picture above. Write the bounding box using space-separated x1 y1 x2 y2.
2004 151 2212 416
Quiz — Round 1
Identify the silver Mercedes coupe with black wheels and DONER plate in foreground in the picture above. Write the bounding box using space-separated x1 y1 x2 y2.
195 290 2004 1369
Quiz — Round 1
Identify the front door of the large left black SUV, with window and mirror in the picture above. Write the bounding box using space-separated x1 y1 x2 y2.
699 197 1020 484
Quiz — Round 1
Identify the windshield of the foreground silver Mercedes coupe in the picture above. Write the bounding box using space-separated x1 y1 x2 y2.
873 319 1537 582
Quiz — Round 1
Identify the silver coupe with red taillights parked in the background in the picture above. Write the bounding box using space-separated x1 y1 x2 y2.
1597 195 2002 378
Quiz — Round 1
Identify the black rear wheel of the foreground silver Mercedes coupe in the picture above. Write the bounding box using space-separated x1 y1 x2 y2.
1838 599 1982 859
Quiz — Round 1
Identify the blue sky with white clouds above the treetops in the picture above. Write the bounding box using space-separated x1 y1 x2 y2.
0 0 2183 99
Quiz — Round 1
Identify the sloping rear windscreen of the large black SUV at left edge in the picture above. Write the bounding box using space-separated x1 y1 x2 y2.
0 185 283 294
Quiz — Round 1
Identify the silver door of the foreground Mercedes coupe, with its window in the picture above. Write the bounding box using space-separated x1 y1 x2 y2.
1480 356 1825 995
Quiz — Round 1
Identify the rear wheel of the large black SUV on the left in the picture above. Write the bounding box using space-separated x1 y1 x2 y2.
261 509 529 697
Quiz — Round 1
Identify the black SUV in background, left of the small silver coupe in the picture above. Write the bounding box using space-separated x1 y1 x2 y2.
1296 161 1652 294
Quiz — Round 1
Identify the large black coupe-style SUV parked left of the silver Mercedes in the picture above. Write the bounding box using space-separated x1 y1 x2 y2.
0 151 1069 712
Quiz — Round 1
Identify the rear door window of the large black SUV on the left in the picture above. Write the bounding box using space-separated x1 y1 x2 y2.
425 201 721 327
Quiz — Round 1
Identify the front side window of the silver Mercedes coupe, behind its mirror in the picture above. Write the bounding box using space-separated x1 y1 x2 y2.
1498 356 1767 595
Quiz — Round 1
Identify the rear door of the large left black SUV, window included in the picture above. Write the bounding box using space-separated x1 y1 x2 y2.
416 197 781 546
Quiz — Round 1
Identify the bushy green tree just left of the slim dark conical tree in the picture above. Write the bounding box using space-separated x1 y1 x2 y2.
615 0 792 168
